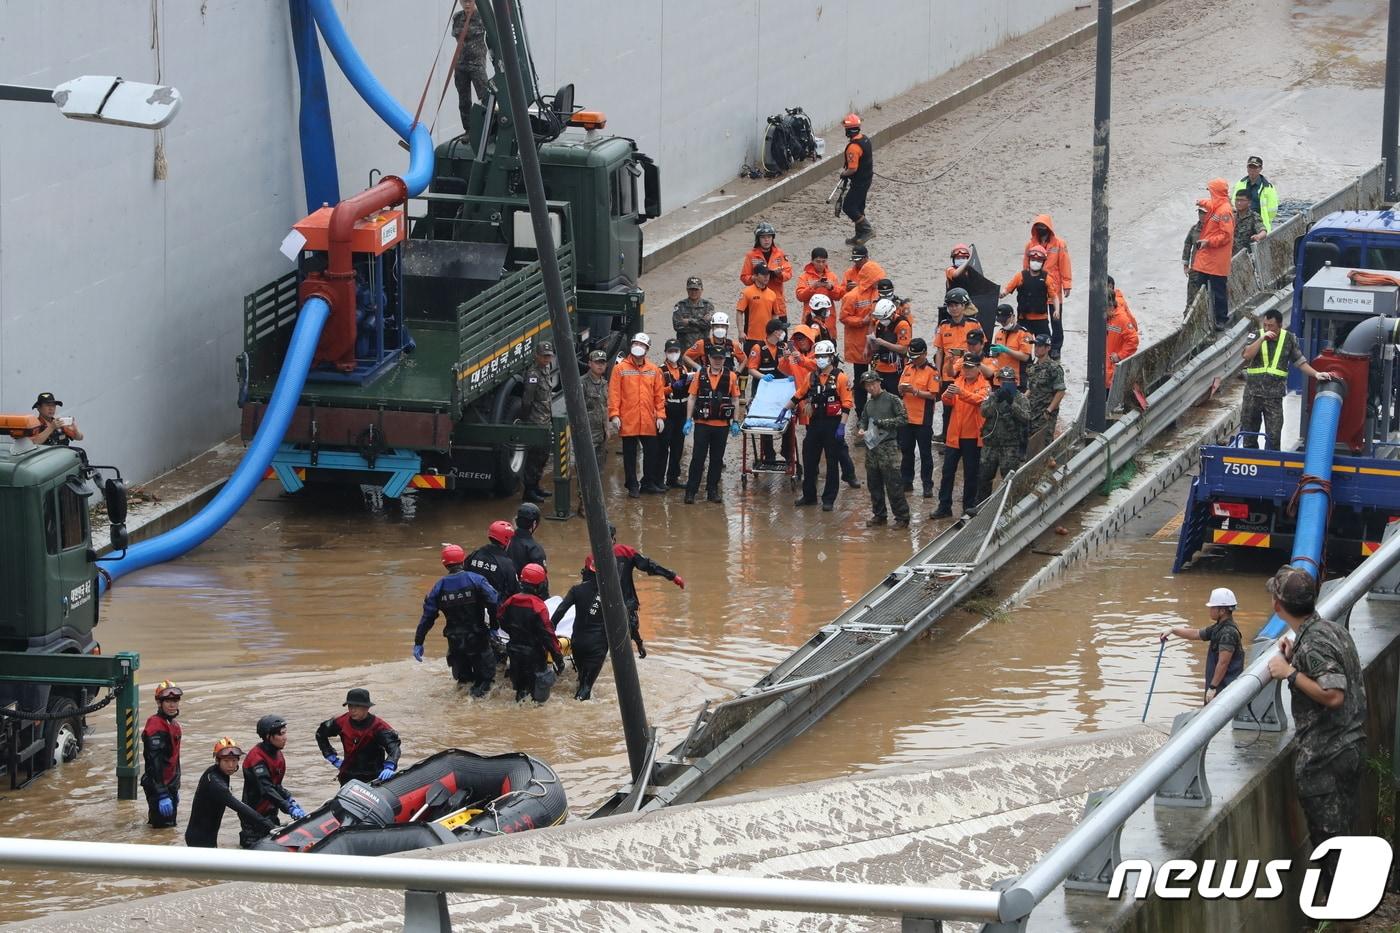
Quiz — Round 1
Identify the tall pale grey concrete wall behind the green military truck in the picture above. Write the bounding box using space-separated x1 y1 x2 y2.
0 0 1074 482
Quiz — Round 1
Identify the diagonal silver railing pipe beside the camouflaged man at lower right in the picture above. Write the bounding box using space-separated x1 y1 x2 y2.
1001 518 1400 922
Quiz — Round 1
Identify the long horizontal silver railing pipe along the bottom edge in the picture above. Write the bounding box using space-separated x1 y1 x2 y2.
0 839 1000 920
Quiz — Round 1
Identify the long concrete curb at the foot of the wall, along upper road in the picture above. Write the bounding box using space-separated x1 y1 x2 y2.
641 0 1165 273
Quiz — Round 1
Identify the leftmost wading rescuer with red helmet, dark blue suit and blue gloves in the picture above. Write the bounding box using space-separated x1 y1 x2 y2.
413 545 501 698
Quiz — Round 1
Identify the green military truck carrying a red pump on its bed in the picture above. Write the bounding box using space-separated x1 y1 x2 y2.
238 3 661 517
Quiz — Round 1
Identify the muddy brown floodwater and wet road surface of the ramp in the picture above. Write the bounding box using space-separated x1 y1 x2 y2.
0 0 1383 919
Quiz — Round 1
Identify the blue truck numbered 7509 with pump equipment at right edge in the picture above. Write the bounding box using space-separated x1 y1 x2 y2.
1172 210 1400 573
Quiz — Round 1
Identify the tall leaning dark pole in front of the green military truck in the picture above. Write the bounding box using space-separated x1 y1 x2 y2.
494 0 651 780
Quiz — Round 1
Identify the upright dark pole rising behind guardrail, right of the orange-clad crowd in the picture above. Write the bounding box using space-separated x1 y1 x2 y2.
1080 0 1113 433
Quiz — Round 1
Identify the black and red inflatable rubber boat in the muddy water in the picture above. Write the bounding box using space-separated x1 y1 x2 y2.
255 748 568 856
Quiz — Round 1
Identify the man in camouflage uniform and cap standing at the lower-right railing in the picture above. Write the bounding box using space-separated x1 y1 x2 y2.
1268 566 1366 902
